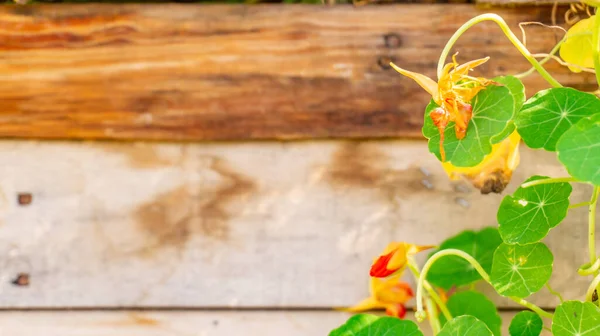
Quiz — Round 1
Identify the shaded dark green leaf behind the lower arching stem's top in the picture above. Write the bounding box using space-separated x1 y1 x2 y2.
427 228 502 290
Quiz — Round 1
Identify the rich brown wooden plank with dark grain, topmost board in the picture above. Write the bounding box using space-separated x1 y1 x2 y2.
0 5 596 140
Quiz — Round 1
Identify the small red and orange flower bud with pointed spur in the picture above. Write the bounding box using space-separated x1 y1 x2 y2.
369 242 434 278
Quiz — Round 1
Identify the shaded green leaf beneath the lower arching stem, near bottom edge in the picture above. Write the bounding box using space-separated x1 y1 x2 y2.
440 291 502 336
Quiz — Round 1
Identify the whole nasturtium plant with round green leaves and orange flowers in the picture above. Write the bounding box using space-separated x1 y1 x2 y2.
331 0 600 336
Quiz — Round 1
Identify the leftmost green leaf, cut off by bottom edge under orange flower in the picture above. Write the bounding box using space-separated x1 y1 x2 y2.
329 314 423 336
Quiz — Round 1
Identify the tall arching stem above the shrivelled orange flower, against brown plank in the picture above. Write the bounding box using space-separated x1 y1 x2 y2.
437 13 562 87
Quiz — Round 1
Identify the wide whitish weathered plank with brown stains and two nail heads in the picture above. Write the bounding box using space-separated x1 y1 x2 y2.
0 141 589 308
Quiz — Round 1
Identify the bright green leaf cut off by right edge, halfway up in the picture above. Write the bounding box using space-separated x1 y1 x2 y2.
556 113 600 185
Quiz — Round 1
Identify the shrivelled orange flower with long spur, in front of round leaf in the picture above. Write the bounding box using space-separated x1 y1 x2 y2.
390 54 494 162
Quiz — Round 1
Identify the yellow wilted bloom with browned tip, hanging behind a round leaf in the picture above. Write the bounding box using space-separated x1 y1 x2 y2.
442 131 521 194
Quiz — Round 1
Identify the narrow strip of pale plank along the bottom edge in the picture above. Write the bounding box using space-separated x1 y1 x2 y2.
0 311 550 336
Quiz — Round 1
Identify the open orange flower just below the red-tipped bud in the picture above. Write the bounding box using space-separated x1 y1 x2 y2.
344 273 414 318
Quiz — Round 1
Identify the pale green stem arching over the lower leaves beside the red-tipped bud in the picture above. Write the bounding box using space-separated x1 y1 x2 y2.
415 249 553 322
